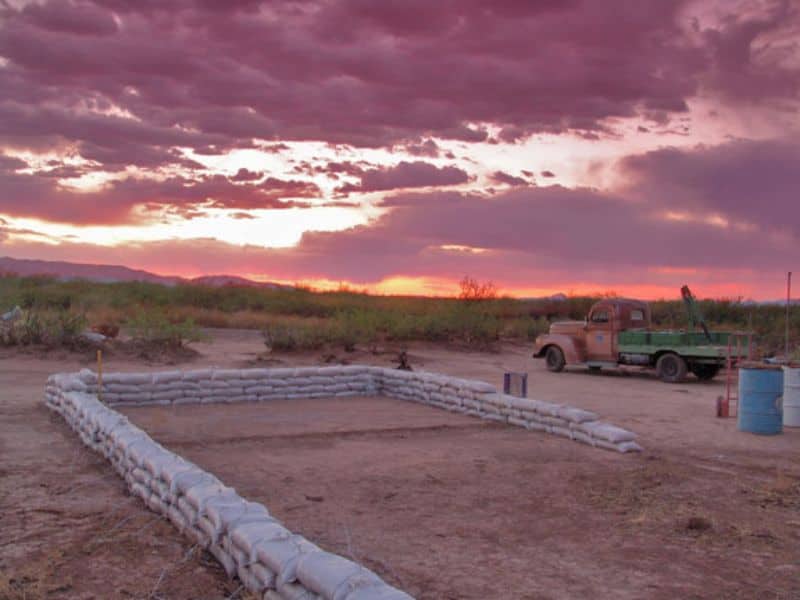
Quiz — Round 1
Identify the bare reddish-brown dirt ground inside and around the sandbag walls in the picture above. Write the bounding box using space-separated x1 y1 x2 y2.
0 330 800 599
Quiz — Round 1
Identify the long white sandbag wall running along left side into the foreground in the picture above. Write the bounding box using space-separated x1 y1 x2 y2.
45 370 411 600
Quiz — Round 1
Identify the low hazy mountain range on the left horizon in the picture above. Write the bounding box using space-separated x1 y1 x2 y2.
0 256 291 289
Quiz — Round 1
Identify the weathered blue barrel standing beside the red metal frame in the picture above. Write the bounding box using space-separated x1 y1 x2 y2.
737 367 783 435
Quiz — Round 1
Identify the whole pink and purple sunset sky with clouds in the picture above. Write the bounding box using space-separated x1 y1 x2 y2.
0 0 800 299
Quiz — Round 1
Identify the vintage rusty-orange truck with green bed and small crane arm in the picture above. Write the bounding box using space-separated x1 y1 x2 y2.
533 286 750 383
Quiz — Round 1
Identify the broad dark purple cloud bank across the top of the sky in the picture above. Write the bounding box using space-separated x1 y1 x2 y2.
0 0 800 167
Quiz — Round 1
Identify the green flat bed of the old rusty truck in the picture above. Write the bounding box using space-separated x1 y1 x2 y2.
618 331 747 358
